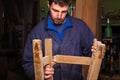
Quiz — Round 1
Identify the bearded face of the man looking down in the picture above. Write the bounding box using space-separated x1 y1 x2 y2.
48 2 69 24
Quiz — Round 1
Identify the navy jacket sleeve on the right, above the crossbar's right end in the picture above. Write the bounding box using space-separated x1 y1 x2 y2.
81 22 95 56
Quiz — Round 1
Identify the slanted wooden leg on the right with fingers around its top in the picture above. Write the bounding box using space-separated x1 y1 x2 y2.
87 42 105 80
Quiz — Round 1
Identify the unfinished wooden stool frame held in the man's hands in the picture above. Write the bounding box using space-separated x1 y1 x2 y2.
33 39 105 80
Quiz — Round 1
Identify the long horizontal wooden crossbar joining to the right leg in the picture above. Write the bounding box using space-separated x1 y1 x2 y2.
53 55 91 65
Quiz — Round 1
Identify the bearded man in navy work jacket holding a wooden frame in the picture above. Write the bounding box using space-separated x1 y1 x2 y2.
23 0 96 80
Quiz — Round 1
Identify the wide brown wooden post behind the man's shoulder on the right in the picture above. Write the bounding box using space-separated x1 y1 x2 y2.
75 0 101 39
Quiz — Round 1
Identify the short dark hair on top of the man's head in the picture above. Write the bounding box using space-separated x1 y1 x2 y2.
48 0 71 6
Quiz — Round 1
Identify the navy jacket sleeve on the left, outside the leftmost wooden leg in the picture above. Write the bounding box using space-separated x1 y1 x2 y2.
22 35 34 80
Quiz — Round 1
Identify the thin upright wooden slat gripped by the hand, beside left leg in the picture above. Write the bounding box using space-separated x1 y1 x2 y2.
45 39 53 80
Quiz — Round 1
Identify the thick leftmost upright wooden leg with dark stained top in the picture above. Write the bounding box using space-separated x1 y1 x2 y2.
33 39 44 80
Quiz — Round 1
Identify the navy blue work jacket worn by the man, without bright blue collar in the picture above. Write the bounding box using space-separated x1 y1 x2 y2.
23 16 95 80
